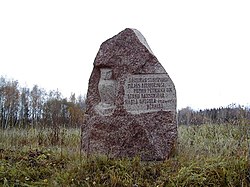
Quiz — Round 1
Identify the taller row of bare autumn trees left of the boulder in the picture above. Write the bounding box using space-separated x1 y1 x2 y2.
0 77 85 129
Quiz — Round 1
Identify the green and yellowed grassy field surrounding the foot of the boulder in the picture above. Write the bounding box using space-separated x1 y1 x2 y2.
0 124 250 187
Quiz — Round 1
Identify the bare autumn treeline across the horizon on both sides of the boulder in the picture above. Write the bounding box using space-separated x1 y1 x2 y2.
0 77 250 129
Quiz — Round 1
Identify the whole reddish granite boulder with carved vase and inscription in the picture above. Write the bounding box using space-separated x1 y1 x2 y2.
82 29 177 160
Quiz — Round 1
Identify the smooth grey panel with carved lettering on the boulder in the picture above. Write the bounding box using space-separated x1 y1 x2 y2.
124 74 176 114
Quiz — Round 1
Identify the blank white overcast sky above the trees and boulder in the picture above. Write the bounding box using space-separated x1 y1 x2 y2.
0 0 250 109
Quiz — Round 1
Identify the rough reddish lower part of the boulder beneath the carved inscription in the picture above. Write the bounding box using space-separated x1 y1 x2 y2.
82 111 177 160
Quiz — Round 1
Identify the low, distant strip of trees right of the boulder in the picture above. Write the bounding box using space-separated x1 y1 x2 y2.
178 104 250 125
